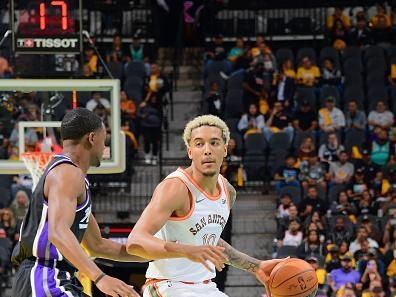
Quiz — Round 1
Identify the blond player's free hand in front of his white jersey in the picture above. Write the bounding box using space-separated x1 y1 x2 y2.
186 245 228 272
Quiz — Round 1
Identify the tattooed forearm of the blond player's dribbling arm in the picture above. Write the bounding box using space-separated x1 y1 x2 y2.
217 239 260 273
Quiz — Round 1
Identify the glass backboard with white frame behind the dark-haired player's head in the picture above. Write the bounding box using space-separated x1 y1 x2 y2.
0 79 125 174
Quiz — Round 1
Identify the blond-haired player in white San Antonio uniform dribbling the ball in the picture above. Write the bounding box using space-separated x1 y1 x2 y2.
127 115 282 297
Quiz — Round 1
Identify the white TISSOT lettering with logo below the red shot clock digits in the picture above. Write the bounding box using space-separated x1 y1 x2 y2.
17 38 78 49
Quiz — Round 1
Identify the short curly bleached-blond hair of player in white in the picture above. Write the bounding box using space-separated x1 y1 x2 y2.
183 114 230 147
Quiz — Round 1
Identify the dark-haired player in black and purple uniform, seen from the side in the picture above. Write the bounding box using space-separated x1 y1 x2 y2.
12 108 142 297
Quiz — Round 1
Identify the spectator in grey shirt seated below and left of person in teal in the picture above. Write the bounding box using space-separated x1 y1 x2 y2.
329 151 355 185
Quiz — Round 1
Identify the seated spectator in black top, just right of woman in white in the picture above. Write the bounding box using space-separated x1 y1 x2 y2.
263 101 294 143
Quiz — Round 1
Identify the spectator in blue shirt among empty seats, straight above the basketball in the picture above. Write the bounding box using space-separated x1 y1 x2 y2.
274 155 300 193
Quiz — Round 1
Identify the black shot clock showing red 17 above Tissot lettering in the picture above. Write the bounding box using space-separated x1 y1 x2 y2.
11 0 82 54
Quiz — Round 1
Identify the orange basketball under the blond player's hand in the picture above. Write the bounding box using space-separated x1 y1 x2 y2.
268 258 318 297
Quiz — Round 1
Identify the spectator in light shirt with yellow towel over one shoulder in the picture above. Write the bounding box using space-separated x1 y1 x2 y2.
319 96 345 133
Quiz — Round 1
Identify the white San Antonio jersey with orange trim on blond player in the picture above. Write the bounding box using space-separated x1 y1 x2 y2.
146 168 230 283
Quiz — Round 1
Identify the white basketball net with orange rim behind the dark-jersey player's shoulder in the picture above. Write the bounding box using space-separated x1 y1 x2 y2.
21 152 55 192
